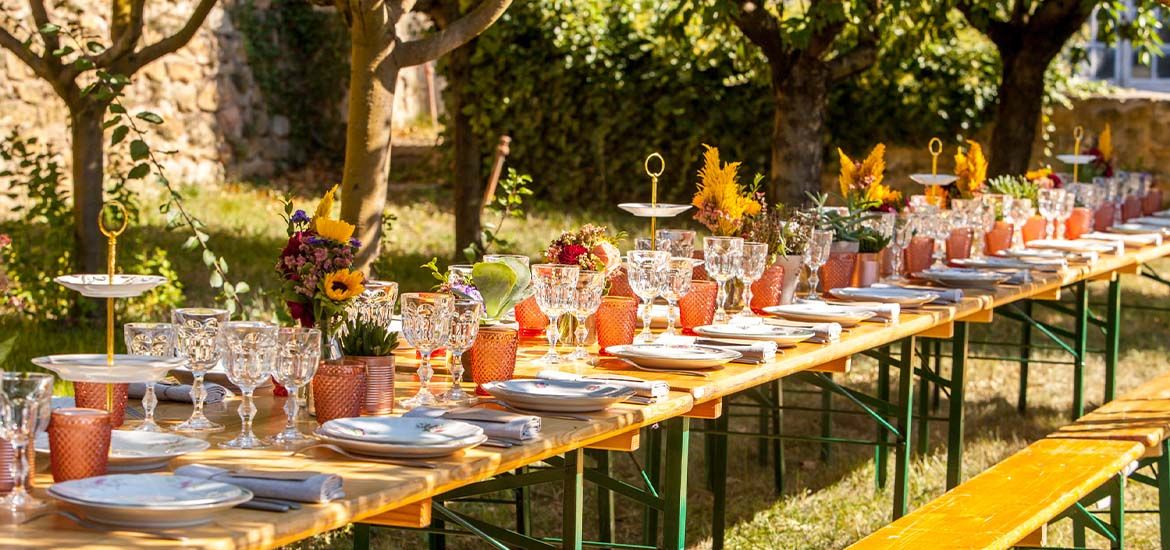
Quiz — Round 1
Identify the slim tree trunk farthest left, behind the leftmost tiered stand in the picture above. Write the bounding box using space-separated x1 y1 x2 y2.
69 101 106 273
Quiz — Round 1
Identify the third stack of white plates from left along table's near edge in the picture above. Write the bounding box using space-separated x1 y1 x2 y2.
483 378 636 412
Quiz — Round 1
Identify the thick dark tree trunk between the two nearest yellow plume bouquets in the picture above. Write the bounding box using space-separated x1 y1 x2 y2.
769 56 831 205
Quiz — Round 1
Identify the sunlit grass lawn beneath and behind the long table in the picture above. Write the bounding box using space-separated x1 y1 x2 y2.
0 180 1170 549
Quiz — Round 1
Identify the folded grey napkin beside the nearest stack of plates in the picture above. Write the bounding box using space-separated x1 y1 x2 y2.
174 465 345 502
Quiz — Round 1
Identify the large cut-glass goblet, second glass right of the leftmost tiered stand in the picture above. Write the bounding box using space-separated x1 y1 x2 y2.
171 308 230 432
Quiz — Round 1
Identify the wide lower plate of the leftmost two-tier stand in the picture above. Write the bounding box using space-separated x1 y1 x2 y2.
33 353 184 384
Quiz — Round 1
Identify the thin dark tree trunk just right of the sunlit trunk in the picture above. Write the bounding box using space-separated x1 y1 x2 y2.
447 40 483 257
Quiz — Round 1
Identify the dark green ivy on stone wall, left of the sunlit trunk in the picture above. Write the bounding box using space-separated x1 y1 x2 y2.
228 0 349 165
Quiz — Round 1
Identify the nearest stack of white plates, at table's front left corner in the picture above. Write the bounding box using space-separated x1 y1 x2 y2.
49 474 252 529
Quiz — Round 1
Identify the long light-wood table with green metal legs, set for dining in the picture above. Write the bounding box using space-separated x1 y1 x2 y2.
9 238 1170 548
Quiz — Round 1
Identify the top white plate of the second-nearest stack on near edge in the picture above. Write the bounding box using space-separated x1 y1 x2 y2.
321 417 483 446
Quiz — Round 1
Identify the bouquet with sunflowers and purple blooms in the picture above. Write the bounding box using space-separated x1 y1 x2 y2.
276 185 365 337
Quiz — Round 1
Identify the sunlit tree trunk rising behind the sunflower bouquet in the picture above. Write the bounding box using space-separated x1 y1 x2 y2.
342 32 399 274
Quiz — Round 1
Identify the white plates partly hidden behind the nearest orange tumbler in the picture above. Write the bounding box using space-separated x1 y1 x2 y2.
33 429 211 473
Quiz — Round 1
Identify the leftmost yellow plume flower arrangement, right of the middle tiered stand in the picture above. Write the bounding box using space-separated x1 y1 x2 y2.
690 144 764 236
